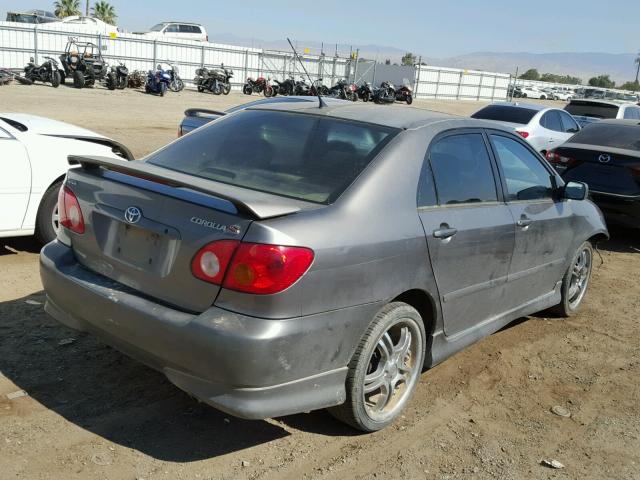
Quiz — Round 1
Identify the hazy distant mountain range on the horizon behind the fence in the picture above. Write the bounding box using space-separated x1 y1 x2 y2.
213 34 636 84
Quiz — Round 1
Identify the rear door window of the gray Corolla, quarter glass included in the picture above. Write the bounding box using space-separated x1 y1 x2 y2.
429 133 498 205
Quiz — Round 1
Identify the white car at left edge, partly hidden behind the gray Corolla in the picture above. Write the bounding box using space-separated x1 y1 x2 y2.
0 113 133 243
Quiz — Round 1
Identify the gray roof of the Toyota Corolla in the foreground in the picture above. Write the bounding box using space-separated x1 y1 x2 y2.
248 99 512 131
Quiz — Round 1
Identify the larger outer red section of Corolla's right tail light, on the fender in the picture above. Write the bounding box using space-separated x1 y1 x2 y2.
223 243 314 295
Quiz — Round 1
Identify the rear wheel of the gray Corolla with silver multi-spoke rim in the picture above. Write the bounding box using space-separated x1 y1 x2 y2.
329 302 426 432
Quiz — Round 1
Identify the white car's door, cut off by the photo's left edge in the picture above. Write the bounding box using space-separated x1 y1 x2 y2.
0 128 31 232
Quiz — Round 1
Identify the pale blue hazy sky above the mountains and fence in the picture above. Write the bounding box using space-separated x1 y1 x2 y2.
0 0 640 57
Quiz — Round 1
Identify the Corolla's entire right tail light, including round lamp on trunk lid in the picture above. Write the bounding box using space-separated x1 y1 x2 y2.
191 240 314 295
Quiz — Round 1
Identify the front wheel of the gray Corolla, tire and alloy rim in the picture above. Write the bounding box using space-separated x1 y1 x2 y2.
552 241 593 317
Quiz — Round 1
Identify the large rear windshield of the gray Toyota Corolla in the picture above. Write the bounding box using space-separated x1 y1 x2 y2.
146 110 398 203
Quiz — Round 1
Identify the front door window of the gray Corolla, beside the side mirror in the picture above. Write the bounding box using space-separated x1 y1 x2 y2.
491 135 552 201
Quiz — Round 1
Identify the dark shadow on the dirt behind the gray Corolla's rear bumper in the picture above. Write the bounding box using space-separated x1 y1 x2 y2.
0 292 357 462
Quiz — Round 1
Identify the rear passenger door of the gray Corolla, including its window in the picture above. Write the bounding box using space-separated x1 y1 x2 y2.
418 130 514 336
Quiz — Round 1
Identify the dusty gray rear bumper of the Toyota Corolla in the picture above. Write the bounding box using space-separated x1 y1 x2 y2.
40 241 380 419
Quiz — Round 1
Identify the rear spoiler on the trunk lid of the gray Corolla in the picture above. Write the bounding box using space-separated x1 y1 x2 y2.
68 155 304 220
